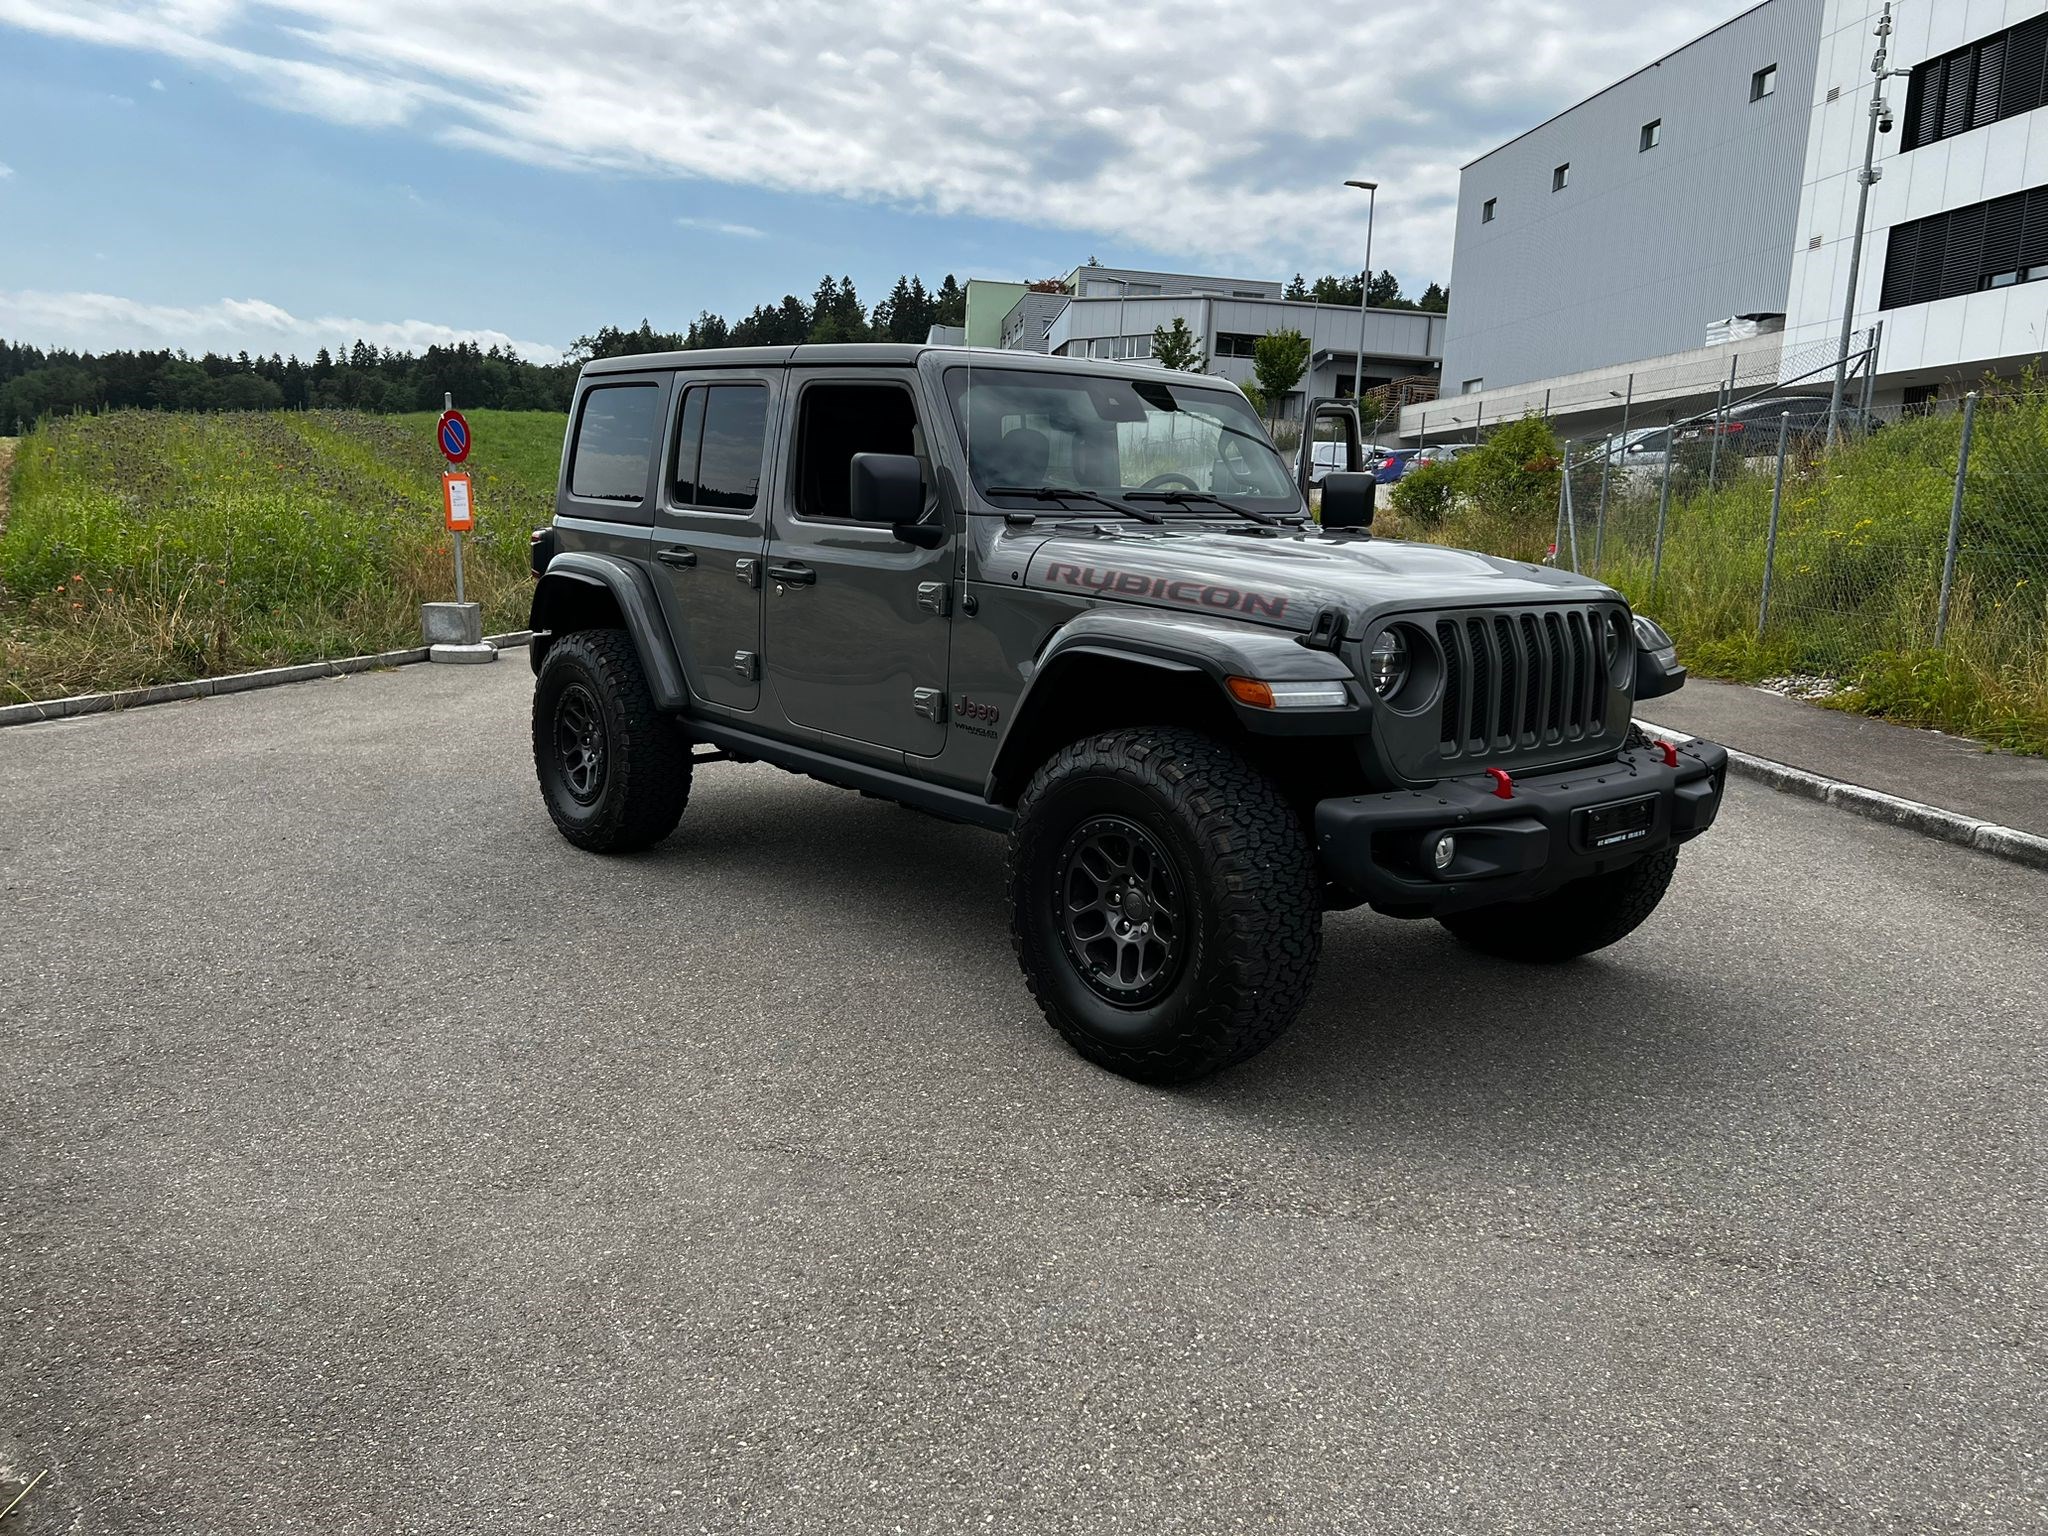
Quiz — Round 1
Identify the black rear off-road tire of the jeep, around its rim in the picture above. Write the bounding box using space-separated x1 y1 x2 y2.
532 629 690 854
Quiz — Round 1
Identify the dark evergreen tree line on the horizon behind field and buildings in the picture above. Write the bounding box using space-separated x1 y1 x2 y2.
0 272 1450 436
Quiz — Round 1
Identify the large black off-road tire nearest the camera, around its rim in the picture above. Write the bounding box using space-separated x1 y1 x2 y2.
1010 727 1323 1083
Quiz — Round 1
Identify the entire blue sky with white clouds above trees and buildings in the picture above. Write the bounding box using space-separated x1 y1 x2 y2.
0 0 1747 356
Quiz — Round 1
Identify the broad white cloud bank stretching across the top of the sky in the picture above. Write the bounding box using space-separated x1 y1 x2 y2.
0 0 1737 279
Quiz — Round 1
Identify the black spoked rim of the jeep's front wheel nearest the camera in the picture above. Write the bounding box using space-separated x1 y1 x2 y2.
1053 815 1188 1008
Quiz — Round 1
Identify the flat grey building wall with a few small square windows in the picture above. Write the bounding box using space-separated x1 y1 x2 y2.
1442 0 1825 395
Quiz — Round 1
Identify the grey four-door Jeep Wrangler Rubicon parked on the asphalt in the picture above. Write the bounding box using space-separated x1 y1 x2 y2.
532 346 1726 1081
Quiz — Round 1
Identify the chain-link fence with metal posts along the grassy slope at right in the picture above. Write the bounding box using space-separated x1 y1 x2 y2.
1552 379 2048 694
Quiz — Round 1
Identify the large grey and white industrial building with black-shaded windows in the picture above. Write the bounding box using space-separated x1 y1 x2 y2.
1401 0 2048 440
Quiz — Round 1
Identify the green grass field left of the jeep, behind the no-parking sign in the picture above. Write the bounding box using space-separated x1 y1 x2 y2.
0 412 563 702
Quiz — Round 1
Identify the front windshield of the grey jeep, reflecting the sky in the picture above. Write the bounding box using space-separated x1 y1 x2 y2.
946 369 1298 512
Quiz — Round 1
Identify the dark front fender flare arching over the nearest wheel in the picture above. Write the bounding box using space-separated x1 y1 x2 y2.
987 606 1372 797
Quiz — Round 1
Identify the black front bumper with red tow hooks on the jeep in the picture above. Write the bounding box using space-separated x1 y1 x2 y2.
1315 741 1729 918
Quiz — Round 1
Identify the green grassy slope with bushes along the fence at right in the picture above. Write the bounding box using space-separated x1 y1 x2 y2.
1378 391 2048 754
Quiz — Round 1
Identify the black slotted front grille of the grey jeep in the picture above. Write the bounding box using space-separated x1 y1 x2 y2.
1436 604 1632 762
